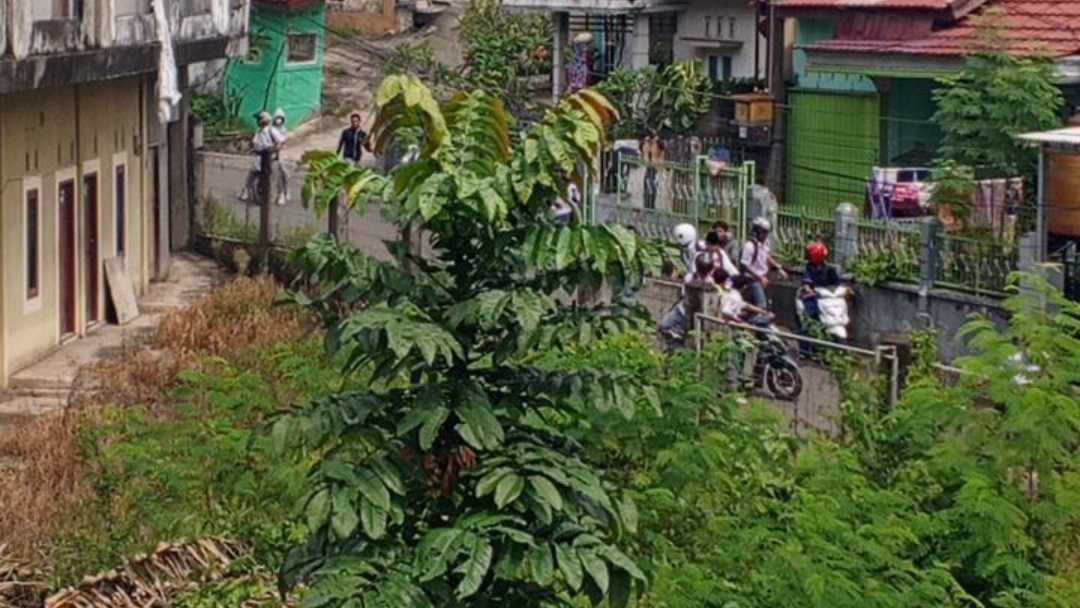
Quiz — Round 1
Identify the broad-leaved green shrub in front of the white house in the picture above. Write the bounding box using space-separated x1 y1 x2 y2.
597 62 713 137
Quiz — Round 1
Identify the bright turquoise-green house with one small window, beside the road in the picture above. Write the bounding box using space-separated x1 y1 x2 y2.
227 0 326 129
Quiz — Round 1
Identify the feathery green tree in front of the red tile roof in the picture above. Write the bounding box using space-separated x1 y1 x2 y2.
934 11 1064 184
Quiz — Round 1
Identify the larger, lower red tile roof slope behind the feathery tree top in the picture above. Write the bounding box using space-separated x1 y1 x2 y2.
795 0 1080 57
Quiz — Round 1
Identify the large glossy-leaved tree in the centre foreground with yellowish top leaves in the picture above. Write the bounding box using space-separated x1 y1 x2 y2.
274 77 658 608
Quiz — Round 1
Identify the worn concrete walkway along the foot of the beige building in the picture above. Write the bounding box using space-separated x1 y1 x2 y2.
0 253 225 433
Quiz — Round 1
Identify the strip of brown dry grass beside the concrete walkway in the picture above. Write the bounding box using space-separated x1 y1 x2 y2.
0 278 311 570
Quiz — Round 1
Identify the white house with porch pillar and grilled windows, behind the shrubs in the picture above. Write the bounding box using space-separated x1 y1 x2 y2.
503 0 768 97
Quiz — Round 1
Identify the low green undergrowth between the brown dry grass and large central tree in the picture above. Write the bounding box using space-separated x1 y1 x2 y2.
51 340 340 582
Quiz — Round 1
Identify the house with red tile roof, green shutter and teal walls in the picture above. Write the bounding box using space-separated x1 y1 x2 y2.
773 0 1080 213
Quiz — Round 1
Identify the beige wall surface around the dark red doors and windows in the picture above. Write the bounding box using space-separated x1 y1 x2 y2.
0 78 149 384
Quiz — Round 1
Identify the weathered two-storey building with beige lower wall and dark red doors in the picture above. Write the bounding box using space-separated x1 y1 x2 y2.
0 0 248 386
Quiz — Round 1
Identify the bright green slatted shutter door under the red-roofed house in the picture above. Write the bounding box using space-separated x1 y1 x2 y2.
786 91 881 217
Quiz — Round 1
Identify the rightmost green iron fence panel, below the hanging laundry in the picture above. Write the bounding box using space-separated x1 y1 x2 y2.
932 234 1020 296
